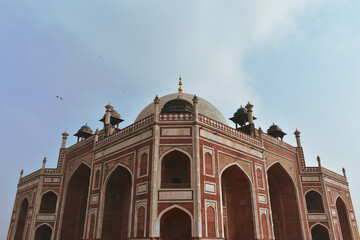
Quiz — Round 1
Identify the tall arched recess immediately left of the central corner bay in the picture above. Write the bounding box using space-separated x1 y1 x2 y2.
102 166 132 240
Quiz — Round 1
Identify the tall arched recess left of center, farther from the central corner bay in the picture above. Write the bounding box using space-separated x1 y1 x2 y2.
60 163 90 240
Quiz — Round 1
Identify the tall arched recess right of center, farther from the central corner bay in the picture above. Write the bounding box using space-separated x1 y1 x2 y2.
267 163 302 240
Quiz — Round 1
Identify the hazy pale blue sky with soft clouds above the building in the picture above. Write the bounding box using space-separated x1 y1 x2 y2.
0 0 360 239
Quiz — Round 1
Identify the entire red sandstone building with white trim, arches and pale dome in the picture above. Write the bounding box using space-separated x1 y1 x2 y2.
7 93 360 240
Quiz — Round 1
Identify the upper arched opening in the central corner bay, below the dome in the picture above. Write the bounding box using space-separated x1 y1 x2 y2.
161 150 191 188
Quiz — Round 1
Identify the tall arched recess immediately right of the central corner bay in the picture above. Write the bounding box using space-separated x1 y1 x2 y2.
221 165 255 239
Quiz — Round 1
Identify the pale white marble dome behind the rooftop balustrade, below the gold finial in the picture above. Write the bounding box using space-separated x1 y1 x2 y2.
135 93 227 125
